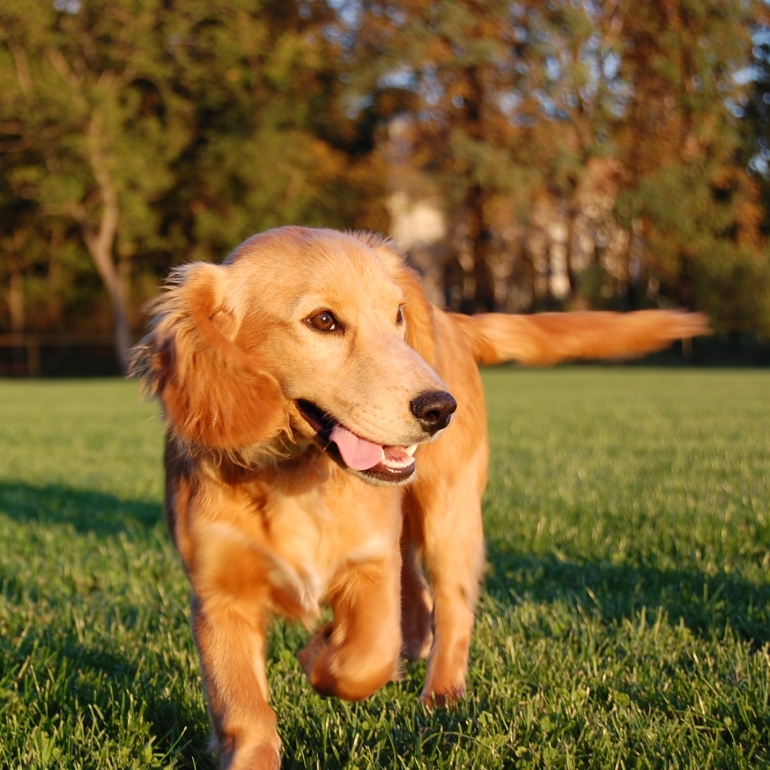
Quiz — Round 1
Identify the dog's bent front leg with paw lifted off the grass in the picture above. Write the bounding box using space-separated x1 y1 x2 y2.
299 548 401 700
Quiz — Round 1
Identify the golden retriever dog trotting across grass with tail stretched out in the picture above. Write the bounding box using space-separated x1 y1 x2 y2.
133 227 706 770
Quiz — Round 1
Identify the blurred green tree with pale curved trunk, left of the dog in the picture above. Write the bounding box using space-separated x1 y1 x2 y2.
0 0 189 369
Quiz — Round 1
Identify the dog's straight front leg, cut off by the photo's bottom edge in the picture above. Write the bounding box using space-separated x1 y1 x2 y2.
193 594 281 770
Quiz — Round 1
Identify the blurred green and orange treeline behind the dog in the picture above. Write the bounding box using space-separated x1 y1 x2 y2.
0 0 770 372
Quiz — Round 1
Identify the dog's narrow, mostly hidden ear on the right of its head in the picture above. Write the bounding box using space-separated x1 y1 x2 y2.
355 233 438 369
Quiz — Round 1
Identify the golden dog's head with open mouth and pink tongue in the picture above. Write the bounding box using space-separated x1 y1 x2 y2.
133 227 456 483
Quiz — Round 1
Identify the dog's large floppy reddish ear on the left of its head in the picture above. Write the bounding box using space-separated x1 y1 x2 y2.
131 262 288 449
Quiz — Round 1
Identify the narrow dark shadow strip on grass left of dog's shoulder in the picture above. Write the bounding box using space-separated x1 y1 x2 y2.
0 481 163 535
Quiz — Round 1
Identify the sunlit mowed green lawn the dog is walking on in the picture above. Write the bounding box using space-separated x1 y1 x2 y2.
0 367 770 770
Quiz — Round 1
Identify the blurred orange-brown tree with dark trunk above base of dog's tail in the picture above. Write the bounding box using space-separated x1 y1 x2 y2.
347 0 531 310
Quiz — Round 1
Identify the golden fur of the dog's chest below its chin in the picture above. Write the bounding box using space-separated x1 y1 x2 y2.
169 453 402 624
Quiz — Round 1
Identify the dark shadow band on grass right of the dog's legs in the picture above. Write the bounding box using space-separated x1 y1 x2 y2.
486 540 770 647
